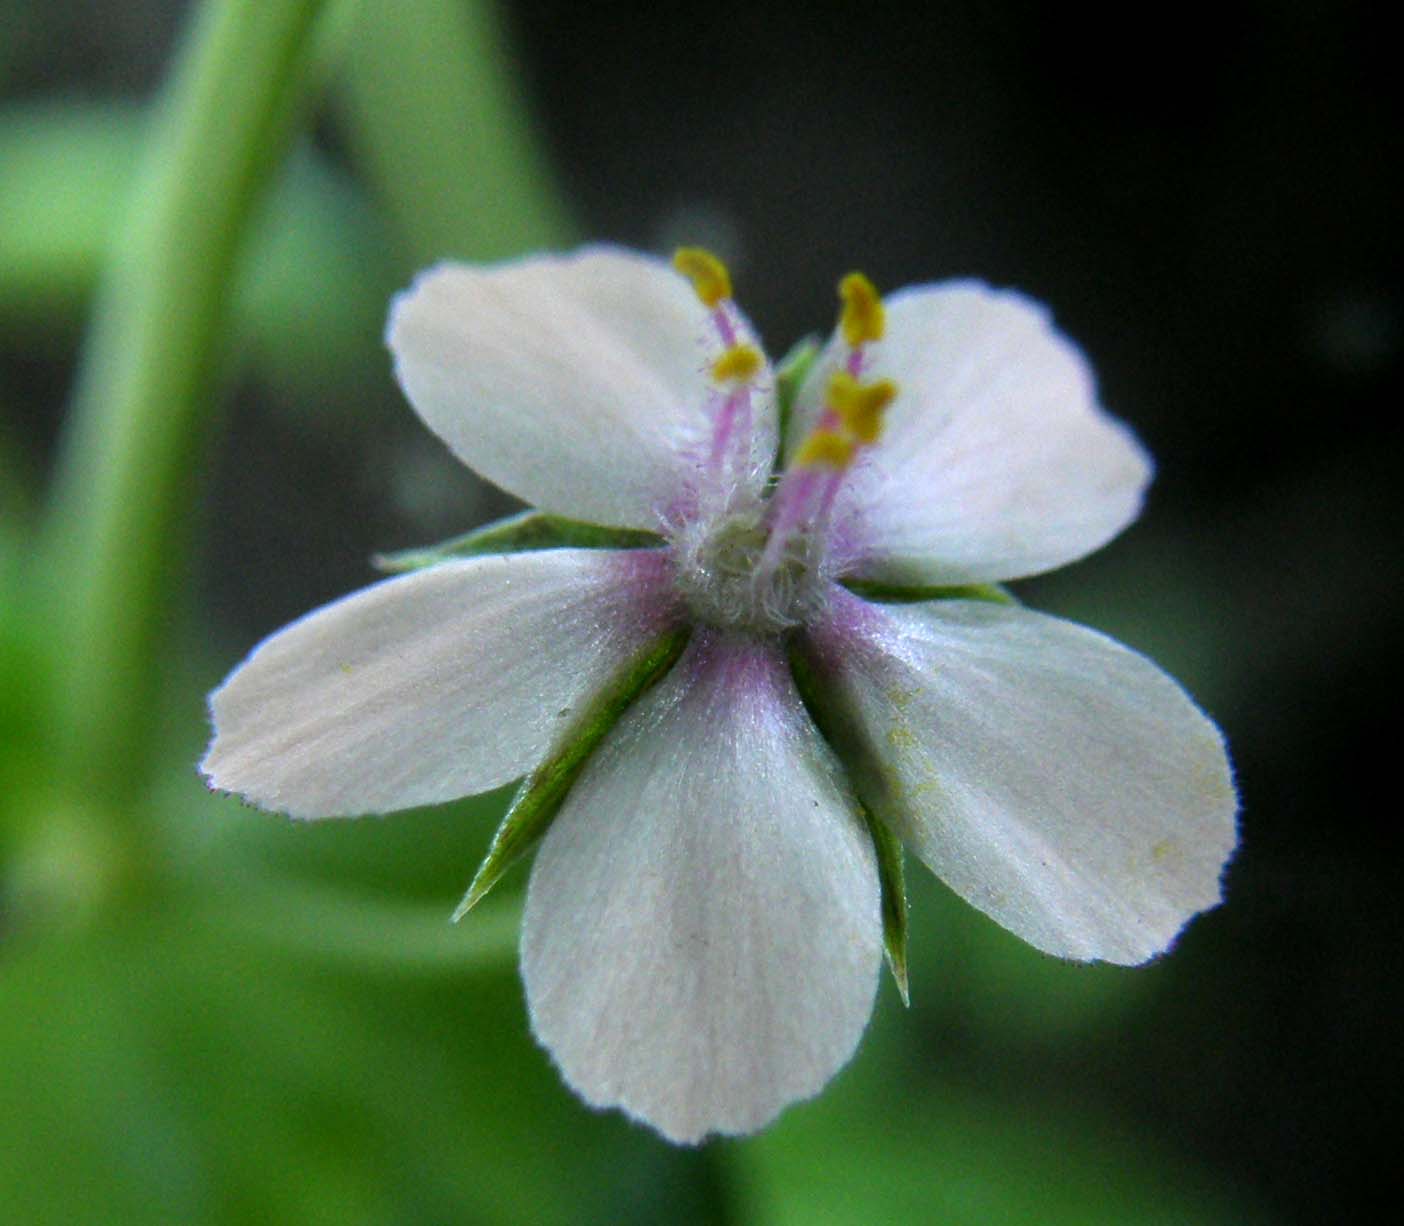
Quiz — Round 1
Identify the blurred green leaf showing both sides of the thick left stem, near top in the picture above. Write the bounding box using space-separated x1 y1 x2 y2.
0 103 395 404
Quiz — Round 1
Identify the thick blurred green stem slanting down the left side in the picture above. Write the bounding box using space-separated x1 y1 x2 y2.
39 0 343 831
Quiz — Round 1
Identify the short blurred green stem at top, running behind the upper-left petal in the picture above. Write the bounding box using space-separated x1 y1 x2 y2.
338 0 573 268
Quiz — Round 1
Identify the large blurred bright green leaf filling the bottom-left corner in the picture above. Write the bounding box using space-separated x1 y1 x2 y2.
0 893 724 1226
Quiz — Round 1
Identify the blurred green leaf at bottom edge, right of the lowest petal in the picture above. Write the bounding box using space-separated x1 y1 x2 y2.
727 1011 1266 1226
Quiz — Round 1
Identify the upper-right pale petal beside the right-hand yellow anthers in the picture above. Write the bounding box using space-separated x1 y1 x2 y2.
790 282 1151 586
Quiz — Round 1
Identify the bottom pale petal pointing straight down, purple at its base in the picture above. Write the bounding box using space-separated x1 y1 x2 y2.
522 633 882 1142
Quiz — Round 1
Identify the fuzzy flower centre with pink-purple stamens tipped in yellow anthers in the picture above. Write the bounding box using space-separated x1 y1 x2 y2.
668 247 897 636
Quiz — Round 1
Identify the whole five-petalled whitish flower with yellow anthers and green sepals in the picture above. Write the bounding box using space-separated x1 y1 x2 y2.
202 249 1237 1142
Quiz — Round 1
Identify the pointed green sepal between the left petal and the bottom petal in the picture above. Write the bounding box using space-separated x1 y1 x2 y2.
453 626 689 923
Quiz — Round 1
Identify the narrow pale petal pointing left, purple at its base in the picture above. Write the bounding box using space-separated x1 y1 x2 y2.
201 549 673 817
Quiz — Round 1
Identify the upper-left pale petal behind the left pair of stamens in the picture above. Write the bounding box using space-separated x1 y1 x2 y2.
388 247 776 529
